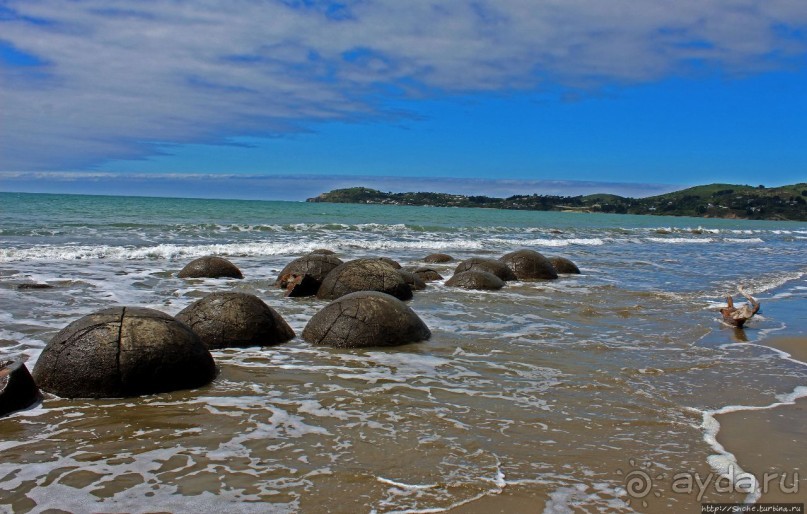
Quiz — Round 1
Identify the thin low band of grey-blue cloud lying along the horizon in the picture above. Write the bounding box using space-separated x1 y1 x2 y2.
0 171 682 201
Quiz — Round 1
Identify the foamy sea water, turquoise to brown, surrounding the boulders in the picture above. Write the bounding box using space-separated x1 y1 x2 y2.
0 193 807 513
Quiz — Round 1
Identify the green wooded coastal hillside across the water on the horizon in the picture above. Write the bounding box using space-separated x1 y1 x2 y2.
306 183 807 221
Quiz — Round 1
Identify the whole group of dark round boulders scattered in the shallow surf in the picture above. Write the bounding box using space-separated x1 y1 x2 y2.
15 249 580 400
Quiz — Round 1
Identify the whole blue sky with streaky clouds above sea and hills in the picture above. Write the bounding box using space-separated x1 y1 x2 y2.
0 0 807 200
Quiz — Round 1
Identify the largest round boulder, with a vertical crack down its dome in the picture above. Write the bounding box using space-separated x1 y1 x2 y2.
33 307 216 398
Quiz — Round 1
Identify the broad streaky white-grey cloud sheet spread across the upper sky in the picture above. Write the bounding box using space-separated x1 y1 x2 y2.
0 0 807 170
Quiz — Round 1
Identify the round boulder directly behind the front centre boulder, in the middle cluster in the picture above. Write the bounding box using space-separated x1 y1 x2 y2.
317 259 412 300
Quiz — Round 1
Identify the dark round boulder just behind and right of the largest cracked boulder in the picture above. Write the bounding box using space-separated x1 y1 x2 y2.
176 292 294 349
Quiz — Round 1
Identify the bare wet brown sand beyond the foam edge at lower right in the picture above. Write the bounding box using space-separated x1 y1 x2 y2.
716 337 807 503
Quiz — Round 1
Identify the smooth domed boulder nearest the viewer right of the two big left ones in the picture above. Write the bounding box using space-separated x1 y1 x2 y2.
303 291 431 348
